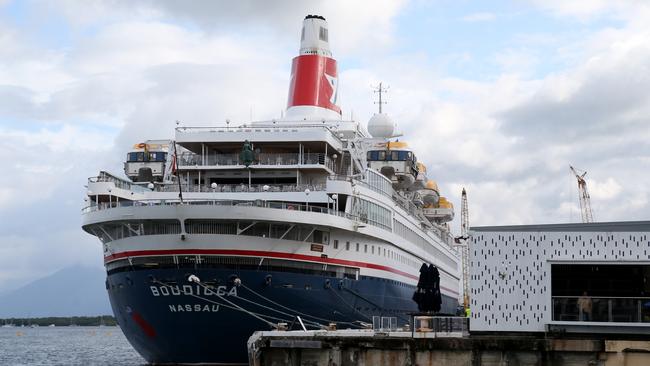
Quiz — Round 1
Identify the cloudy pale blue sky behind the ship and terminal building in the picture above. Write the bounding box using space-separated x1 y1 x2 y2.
0 0 650 293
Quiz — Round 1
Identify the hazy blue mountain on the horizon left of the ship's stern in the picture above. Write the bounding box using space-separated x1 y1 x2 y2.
0 266 112 318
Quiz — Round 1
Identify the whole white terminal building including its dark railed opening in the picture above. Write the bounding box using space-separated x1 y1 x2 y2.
470 221 650 334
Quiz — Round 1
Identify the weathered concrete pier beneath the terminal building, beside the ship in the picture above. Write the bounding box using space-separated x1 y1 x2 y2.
248 330 650 366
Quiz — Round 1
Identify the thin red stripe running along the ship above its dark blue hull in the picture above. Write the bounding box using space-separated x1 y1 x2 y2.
104 249 458 296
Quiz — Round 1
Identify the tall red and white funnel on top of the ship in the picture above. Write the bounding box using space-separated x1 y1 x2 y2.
287 15 341 120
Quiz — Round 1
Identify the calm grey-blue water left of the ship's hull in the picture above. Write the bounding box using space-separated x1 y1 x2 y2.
0 327 146 366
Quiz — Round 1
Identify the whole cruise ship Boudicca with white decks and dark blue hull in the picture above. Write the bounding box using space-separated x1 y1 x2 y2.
82 15 461 364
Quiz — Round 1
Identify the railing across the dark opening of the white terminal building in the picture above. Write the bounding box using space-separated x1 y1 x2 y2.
553 296 650 323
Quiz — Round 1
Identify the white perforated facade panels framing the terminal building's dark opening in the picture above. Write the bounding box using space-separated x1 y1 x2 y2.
470 221 650 332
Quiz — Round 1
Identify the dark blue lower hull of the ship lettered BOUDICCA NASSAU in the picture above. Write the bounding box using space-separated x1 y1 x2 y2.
107 268 458 363
